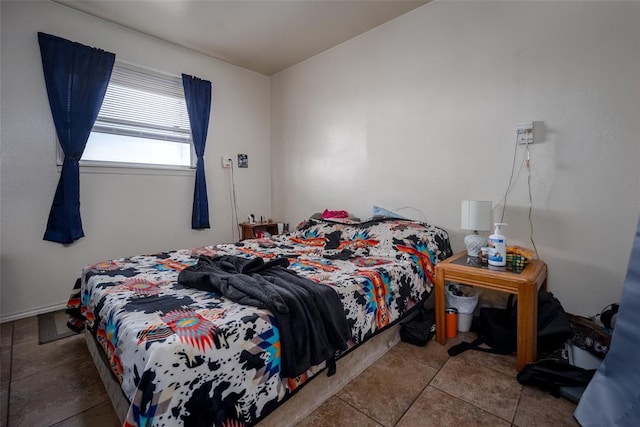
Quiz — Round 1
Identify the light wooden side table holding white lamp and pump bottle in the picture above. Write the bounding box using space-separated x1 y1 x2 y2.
435 251 547 371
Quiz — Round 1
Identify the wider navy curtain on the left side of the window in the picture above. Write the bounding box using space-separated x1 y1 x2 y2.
38 33 116 243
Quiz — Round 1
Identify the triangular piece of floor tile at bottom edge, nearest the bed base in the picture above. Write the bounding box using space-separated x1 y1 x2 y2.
296 396 380 427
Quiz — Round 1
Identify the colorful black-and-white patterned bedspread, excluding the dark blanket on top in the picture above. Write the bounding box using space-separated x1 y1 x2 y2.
70 219 452 426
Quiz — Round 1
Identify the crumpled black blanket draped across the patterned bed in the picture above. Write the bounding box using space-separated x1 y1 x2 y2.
178 255 351 378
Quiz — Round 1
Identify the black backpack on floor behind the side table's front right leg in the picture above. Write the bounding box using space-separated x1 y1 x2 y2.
449 289 571 356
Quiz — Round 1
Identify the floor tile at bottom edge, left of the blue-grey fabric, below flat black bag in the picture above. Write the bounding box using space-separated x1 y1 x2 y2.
514 386 580 427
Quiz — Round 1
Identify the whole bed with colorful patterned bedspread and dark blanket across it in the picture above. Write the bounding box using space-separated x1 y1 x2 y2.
69 218 452 426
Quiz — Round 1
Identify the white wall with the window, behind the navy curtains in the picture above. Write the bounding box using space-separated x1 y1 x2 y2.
0 1 271 321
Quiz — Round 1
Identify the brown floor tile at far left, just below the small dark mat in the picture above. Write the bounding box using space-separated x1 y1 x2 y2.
11 335 85 381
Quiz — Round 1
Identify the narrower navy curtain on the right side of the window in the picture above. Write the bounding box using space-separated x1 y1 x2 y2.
182 74 211 229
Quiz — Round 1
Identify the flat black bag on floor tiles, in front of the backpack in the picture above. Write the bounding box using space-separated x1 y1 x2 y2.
517 359 596 397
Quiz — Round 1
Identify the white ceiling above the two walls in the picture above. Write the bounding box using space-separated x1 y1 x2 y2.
53 0 429 76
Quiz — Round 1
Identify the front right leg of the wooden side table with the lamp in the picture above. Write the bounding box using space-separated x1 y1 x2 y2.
517 283 538 371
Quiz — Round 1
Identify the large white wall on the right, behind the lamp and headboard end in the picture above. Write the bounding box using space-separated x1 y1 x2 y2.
271 2 640 315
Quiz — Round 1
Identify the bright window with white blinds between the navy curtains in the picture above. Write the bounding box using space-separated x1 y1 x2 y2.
70 62 195 167
